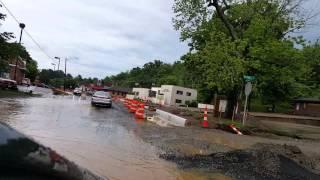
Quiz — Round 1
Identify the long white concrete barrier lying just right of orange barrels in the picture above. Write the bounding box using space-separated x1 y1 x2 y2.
156 109 187 127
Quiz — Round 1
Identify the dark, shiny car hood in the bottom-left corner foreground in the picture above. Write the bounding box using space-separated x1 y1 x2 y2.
0 123 103 180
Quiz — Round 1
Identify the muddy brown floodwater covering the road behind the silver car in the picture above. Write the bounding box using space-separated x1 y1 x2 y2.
0 96 230 179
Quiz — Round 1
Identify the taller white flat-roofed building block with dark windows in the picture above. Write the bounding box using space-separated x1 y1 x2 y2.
161 85 198 106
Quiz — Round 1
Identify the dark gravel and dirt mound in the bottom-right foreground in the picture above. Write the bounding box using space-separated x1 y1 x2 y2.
161 144 320 180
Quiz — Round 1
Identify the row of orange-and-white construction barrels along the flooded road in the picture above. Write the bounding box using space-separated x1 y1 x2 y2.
123 99 145 119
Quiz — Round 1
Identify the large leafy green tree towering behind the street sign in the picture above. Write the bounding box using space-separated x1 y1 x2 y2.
174 0 309 114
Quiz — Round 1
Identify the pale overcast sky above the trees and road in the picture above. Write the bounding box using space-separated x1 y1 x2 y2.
1 0 320 78
